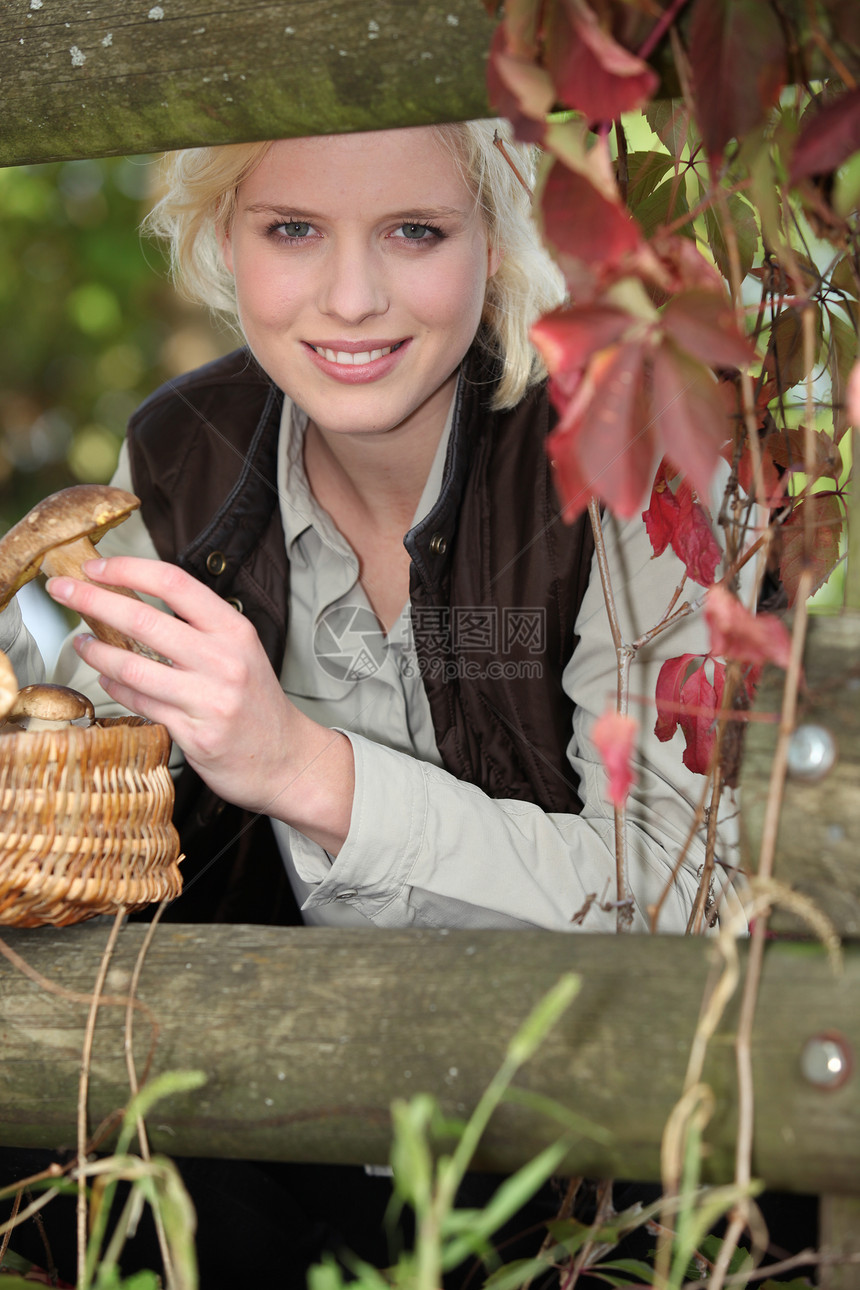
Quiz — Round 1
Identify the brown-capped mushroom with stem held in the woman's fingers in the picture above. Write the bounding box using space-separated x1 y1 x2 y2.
0 484 168 663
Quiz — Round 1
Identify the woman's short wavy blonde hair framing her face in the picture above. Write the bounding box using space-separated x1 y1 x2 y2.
143 120 563 408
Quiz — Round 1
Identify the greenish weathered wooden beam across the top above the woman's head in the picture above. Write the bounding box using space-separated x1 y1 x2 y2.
0 0 494 165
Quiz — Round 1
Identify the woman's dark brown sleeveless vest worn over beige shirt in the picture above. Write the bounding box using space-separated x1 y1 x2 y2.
128 350 593 921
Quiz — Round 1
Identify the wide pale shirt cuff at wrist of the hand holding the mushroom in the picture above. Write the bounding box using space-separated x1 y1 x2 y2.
304 730 428 925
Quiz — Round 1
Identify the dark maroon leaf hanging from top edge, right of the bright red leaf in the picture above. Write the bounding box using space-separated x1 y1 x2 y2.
690 0 787 165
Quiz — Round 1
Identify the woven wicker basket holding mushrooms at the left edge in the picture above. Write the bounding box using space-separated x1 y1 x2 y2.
0 717 182 928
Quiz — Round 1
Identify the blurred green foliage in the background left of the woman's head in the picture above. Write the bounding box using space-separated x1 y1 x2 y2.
0 156 236 657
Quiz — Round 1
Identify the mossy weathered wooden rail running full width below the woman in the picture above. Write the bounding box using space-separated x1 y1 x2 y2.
0 925 860 1195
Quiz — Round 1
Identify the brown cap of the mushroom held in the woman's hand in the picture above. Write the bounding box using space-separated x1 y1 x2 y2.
0 484 141 609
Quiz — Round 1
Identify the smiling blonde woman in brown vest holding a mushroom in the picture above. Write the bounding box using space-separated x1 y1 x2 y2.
49 123 742 930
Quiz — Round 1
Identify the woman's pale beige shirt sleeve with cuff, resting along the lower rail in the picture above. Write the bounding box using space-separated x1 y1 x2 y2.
299 487 739 931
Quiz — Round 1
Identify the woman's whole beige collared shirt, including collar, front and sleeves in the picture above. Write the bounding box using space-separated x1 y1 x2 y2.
57 401 738 931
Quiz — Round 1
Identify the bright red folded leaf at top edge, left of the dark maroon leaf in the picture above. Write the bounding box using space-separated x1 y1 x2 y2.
547 0 659 124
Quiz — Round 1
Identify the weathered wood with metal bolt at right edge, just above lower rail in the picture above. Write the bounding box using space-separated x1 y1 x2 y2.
741 613 860 938
